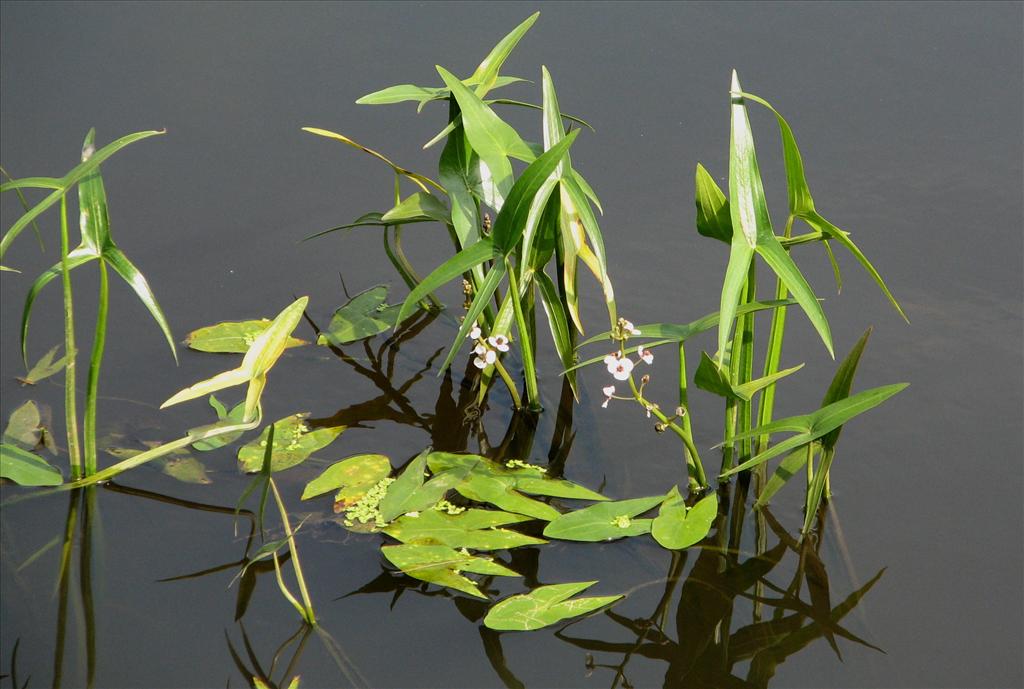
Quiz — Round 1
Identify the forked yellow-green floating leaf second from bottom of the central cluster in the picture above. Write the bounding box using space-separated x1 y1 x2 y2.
384 510 547 550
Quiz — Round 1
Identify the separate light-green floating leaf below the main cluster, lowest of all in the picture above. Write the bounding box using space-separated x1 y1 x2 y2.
483 582 623 632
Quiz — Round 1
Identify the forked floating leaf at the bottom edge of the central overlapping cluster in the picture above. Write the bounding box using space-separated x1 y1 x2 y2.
381 546 519 598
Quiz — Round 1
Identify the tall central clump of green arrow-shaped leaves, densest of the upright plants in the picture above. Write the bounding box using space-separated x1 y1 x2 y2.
304 13 615 410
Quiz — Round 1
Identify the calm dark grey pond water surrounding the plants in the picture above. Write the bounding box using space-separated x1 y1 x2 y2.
0 2 1024 687
